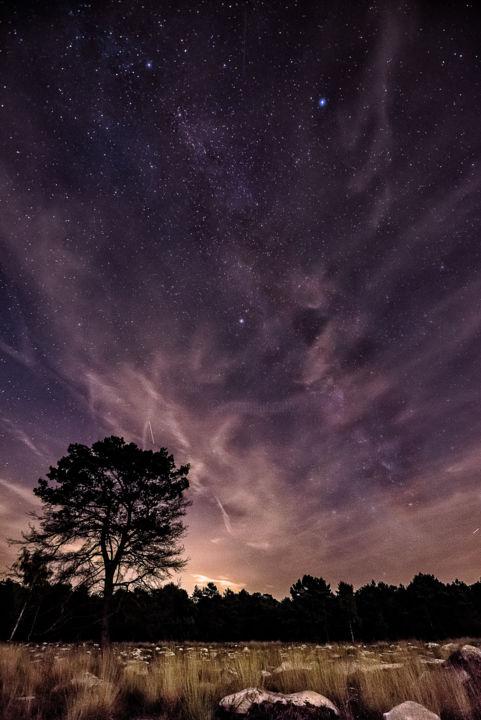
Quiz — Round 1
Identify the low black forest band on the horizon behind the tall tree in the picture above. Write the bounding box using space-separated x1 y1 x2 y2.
0 573 481 643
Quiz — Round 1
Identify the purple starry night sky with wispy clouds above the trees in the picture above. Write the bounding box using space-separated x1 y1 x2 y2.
0 0 481 597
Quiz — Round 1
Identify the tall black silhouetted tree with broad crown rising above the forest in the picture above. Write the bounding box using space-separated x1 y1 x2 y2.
21 436 189 646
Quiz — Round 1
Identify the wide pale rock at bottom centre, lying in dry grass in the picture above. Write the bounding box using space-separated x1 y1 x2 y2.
217 687 339 719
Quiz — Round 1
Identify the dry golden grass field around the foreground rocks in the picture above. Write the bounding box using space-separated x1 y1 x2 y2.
0 640 481 720
